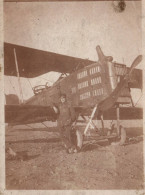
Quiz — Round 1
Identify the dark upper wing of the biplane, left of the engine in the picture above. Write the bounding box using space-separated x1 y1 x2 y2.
4 43 94 78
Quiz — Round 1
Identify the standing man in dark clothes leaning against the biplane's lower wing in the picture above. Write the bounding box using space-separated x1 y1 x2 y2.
54 94 77 154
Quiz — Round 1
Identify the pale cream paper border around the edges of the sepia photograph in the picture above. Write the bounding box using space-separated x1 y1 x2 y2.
0 0 145 195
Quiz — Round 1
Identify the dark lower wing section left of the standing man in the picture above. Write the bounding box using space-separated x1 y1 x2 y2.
5 105 57 124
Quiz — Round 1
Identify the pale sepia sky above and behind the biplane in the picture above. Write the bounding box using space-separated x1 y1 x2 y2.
4 1 142 106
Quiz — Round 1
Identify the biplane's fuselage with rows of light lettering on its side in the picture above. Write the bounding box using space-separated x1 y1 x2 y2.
26 61 130 107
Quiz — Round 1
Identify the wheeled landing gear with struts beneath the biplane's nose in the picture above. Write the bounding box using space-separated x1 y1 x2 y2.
74 104 127 150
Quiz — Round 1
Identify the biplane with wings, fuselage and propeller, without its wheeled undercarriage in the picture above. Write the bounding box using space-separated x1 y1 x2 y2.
4 43 142 146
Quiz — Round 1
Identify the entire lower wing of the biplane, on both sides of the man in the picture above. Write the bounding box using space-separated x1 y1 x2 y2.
5 105 143 125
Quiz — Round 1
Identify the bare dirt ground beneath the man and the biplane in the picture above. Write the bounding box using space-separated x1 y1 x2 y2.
6 122 144 190
